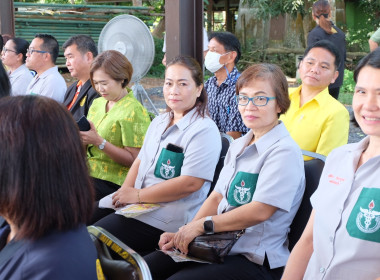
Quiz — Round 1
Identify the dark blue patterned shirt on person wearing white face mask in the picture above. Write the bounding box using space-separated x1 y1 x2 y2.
205 67 249 134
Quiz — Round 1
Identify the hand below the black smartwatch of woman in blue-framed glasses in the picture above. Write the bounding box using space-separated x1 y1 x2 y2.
172 218 204 254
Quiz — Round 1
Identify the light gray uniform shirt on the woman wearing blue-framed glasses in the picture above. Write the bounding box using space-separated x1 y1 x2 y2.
215 122 305 269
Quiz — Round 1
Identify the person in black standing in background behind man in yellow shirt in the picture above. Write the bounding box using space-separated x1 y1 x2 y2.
307 0 346 99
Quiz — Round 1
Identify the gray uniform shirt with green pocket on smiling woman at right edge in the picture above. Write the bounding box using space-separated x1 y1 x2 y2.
304 137 380 280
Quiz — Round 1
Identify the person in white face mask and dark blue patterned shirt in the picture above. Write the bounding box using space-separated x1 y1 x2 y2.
205 32 248 138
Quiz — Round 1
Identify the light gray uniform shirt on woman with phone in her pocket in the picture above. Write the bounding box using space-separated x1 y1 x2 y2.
135 109 222 232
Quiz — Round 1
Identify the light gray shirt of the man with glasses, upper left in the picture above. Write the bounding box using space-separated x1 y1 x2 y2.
26 66 67 103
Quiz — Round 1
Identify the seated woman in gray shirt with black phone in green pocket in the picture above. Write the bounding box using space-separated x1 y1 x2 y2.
95 56 221 254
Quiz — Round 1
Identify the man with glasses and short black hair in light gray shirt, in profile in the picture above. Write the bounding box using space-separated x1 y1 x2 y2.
26 34 67 103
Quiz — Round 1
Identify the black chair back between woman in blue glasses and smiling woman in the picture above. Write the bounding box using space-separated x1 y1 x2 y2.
288 151 326 251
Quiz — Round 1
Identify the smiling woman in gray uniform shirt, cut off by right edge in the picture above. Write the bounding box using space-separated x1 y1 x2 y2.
283 44 380 280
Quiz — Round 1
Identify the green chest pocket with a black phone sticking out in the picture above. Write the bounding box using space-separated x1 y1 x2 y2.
154 148 185 180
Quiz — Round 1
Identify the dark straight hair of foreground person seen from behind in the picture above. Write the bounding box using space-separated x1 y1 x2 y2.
0 95 94 240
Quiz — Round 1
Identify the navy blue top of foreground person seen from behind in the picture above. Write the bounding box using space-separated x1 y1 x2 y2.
0 225 98 280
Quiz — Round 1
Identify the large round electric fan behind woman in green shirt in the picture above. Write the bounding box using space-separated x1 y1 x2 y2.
98 15 158 115
